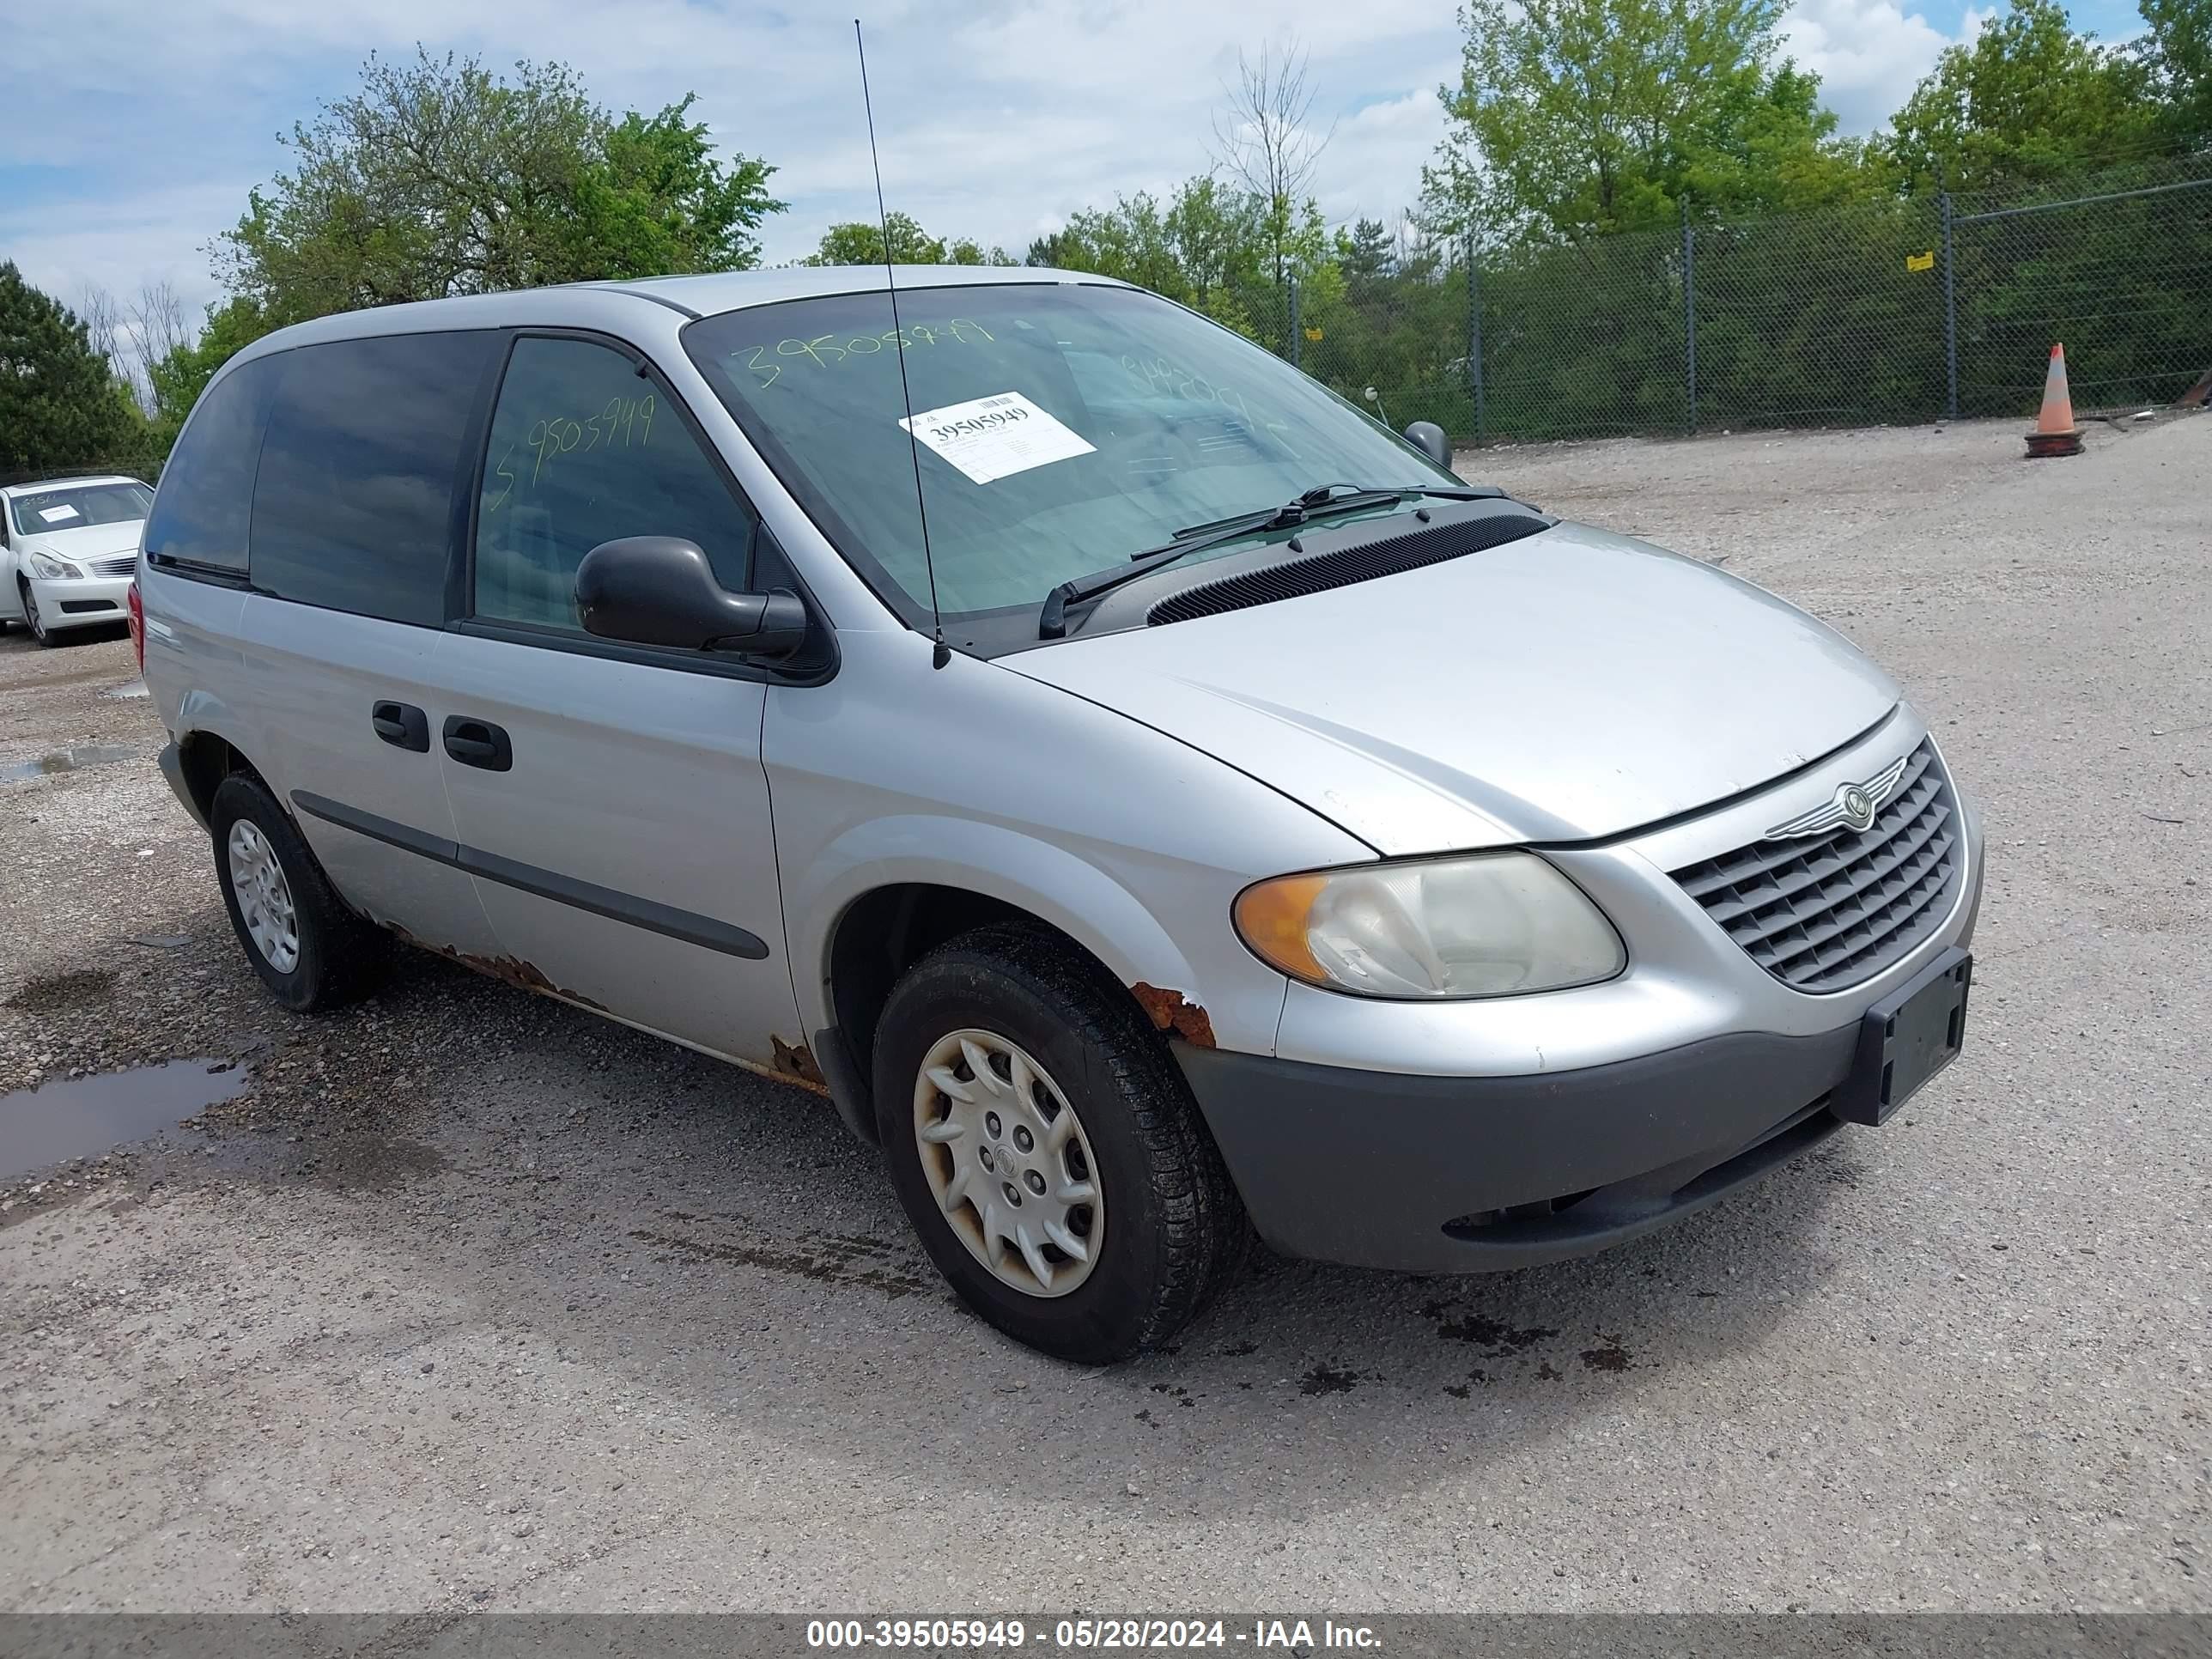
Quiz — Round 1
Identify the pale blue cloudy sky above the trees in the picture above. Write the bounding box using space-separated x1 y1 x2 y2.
0 0 2136 325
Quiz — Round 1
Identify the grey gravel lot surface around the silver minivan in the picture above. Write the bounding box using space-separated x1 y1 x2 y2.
0 418 2212 1614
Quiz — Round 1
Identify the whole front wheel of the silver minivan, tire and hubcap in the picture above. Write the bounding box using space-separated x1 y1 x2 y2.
874 925 1249 1364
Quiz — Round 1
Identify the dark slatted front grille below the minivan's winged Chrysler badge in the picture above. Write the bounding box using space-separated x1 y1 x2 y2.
1674 744 1960 991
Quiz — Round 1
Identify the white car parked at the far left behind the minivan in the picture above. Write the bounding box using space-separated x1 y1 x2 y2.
0 476 153 646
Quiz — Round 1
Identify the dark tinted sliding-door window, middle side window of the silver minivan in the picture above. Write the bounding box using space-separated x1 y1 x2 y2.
252 331 500 626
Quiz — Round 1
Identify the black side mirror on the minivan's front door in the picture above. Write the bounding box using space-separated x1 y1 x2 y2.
575 535 807 657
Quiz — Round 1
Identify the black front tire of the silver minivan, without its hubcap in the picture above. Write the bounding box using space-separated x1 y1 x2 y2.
874 925 1249 1364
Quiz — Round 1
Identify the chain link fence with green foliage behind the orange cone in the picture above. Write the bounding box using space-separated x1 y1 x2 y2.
1239 157 2212 442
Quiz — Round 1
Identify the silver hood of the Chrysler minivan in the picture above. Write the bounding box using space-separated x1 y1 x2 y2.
998 525 1898 856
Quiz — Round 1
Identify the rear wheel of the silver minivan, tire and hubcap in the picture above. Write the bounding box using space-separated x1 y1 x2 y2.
208 772 387 1013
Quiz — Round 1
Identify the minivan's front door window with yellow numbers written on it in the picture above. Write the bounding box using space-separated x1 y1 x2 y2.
476 337 757 633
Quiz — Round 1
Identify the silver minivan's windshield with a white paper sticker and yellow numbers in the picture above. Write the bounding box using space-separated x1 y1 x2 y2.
684 283 1458 622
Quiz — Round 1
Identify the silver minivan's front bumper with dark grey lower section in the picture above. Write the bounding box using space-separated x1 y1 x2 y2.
1175 723 1982 1272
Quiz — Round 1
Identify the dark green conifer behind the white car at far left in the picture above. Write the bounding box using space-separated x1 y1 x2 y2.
0 258 139 471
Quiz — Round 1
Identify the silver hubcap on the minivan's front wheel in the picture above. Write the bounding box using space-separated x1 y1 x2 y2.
914 1030 1106 1297
